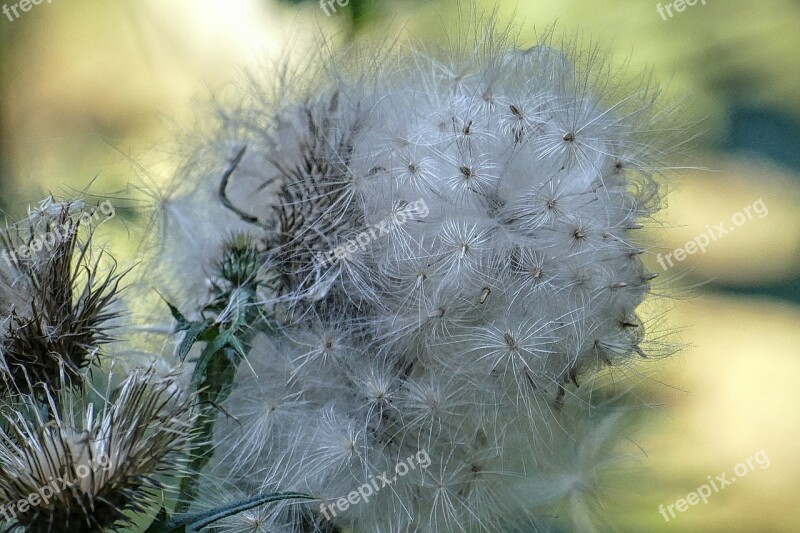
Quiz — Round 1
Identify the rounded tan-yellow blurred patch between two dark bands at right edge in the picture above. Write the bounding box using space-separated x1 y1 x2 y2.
648 156 800 283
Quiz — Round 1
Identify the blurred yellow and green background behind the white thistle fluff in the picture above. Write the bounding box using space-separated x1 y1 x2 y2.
0 0 800 531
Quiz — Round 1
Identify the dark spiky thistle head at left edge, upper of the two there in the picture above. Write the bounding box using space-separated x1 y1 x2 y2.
0 198 125 397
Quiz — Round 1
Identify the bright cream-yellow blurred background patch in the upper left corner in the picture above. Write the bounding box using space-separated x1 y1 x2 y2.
0 0 322 200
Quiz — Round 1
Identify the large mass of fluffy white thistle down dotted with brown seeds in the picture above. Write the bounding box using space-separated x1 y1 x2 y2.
159 26 682 532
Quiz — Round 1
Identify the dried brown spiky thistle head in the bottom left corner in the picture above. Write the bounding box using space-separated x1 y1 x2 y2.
0 371 194 533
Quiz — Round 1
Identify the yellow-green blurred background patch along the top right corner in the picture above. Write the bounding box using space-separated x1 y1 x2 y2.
480 0 800 134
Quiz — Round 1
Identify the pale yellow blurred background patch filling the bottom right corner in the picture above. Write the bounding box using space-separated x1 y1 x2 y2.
618 295 800 531
